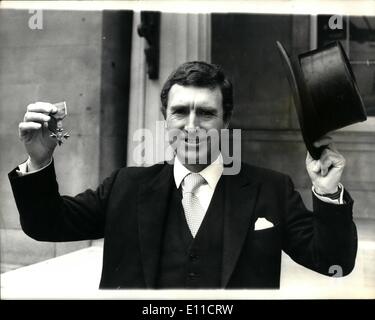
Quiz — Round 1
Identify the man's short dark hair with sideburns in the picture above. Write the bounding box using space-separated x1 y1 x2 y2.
160 61 233 121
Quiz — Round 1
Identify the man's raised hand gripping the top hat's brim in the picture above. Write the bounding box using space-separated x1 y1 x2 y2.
306 136 345 195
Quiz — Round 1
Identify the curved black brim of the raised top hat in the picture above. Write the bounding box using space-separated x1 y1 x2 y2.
276 41 325 160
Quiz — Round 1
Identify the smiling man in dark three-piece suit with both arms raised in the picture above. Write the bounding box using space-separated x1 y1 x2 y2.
9 62 357 288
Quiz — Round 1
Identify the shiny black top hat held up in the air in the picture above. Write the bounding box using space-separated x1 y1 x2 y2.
277 41 367 160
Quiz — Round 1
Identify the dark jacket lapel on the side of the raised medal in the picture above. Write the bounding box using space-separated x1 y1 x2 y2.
137 164 173 288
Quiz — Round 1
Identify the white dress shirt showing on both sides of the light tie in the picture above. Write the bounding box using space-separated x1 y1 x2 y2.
173 154 224 212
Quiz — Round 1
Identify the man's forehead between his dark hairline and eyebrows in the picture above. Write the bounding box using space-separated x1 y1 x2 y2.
168 84 222 107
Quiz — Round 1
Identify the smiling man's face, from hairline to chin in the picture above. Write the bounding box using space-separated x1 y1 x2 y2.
166 84 226 172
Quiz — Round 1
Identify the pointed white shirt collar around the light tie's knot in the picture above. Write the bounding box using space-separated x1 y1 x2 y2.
173 153 224 190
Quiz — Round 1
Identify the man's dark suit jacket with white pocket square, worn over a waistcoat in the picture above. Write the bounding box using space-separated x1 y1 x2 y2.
9 164 357 288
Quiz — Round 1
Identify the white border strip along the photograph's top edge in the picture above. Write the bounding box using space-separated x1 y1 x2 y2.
0 0 375 15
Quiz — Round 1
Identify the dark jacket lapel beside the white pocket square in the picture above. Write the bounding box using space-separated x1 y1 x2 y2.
221 173 259 287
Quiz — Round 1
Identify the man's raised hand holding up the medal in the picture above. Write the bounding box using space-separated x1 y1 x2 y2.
18 102 57 171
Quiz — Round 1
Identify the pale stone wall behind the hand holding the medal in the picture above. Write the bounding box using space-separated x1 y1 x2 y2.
0 10 102 272
